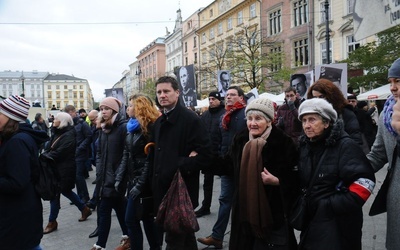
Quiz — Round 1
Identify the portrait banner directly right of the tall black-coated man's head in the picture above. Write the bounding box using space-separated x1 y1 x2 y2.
174 64 197 108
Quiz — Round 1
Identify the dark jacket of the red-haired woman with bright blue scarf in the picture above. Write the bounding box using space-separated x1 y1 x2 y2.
116 128 152 197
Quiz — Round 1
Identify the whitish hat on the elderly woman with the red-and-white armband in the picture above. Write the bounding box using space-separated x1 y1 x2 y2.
299 98 337 121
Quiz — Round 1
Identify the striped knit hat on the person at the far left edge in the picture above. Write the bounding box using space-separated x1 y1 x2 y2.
0 95 30 122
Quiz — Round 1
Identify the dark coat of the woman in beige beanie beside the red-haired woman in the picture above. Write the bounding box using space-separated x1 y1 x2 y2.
96 114 126 198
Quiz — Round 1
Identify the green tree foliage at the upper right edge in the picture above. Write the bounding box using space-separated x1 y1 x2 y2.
342 25 400 89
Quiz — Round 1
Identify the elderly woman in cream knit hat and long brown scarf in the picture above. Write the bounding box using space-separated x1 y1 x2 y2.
229 98 298 250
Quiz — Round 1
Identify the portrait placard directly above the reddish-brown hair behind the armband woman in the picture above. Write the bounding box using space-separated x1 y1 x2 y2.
315 63 347 99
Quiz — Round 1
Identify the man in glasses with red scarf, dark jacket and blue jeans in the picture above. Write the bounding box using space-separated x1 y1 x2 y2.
197 86 246 248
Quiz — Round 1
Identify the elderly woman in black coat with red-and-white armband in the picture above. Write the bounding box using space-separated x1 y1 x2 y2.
289 98 375 250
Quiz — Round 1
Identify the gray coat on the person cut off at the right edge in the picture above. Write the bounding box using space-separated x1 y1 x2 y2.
367 112 400 250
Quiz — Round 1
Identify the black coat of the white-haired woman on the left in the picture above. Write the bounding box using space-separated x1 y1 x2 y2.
45 126 76 192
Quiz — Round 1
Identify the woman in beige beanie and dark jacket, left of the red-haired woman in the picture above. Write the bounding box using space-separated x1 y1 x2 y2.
92 97 129 250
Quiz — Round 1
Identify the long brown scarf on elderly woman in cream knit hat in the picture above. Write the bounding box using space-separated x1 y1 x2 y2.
239 126 273 238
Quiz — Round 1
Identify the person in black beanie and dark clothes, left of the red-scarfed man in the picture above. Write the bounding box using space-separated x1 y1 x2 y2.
195 91 225 217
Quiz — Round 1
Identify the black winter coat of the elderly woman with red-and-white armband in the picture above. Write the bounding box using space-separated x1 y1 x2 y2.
299 120 375 250
